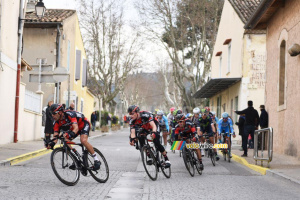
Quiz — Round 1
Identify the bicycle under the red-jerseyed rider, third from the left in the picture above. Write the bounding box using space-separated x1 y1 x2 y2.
181 135 202 177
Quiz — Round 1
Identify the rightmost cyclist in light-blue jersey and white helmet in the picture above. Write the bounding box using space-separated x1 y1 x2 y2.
218 112 235 158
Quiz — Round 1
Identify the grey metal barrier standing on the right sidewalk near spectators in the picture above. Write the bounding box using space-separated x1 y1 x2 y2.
253 127 273 167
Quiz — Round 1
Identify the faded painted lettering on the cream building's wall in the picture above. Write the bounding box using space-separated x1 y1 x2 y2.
248 51 266 89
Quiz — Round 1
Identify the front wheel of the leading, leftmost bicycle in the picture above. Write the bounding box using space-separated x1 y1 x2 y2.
50 148 80 186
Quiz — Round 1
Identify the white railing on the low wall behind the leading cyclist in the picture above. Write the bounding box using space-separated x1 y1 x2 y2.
24 90 41 113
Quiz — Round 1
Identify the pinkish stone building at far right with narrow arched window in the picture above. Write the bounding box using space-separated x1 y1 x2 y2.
245 0 300 158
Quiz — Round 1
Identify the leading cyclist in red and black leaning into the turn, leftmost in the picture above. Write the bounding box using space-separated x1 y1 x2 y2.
45 104 101 170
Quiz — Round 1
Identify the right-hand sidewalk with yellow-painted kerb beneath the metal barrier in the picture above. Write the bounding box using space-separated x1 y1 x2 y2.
232 145 300 184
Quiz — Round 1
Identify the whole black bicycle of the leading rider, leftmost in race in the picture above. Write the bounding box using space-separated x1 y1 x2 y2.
50 134 109 186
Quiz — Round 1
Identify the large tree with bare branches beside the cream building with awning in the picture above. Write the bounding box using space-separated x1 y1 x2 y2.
137 0 223 110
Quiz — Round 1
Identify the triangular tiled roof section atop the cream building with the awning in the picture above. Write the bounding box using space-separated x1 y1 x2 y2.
229 0 262 24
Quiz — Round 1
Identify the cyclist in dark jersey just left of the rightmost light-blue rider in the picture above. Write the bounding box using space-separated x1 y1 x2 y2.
197 109 220 161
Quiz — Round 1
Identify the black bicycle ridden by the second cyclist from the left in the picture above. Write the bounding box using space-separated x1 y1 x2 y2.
137 128 171 181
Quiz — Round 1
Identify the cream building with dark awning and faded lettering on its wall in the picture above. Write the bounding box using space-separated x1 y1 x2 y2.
194 0 266 125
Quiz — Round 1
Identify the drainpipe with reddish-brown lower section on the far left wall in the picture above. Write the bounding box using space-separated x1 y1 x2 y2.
14 0 24 143
